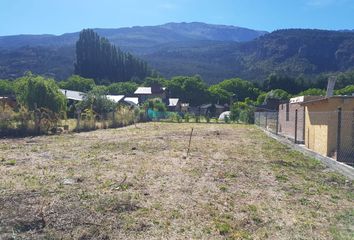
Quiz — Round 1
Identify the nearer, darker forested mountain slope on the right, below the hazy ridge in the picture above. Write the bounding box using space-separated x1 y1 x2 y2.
143 29 354 83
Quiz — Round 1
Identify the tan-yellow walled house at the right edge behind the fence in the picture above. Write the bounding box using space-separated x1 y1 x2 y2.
301 96 354 164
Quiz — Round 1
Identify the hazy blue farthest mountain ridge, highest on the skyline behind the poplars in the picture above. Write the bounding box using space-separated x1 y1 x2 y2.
0 22 267 52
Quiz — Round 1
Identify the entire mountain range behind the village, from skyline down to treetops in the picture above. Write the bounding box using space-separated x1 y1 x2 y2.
0 23 354 83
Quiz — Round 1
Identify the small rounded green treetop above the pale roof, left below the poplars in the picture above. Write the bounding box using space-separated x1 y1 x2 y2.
58 75 96 92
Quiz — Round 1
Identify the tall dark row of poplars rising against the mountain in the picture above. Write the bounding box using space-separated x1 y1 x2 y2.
75 29 151 84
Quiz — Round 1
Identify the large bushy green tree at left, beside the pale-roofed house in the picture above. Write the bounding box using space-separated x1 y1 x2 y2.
15 73 66 113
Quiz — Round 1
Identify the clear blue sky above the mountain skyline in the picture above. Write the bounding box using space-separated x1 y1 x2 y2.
0 0 354 35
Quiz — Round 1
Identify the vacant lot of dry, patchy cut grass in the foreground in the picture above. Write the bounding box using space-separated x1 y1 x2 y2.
0 123 354 239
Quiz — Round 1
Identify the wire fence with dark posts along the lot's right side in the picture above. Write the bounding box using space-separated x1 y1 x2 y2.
255 108 354 166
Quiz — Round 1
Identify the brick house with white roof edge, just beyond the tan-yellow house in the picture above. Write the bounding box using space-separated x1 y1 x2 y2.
278 96 323 143
